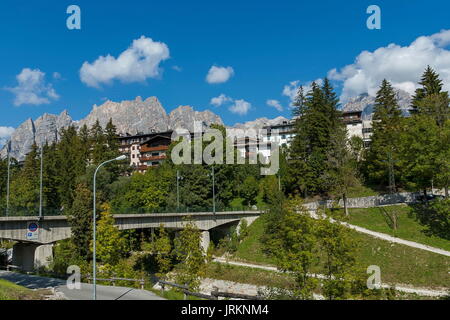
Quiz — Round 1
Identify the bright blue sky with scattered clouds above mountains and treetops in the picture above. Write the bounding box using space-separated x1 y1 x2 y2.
0 0 450 138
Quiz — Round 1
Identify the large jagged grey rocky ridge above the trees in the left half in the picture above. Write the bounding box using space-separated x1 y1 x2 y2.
0 96 223 160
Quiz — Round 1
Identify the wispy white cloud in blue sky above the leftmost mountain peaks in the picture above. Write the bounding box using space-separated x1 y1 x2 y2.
6 68 59 106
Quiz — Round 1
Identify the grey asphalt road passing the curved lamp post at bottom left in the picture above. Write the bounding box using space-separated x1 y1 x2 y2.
0 271 165 300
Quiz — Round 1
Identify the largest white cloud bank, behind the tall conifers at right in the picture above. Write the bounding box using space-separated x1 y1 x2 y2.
328 30 450 102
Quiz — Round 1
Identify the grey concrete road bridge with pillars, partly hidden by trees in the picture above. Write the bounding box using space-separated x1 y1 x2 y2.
0 211 261 271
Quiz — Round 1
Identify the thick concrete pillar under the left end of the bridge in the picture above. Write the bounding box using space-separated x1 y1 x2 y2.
12 242 53 271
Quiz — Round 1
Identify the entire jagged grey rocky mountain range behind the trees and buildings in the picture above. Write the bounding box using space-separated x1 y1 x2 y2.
0 90 411 161
